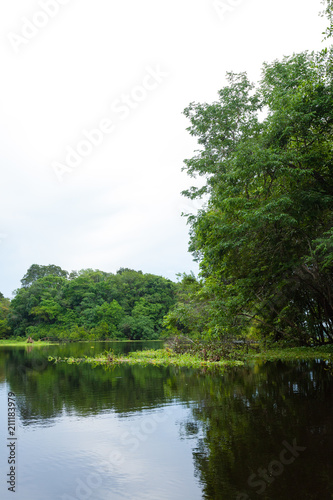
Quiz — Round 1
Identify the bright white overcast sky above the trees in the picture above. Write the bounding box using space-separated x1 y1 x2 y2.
0 0 326 297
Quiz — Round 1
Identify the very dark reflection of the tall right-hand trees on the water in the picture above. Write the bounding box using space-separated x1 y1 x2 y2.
182 361 333 499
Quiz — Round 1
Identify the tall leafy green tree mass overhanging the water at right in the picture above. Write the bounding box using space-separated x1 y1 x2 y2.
183 51 333 343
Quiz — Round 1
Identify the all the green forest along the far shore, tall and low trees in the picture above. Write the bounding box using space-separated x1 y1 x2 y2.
0 0 333 345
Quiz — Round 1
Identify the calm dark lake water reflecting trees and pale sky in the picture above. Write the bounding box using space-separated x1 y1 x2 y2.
0 343 333 500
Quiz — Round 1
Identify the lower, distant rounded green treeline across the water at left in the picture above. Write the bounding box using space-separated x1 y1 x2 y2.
0 264 177 340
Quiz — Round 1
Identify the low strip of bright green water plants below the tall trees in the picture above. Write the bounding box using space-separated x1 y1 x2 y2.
49 346 333 368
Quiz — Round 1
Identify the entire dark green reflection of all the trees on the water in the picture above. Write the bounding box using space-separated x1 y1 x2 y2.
0 348 333 500
